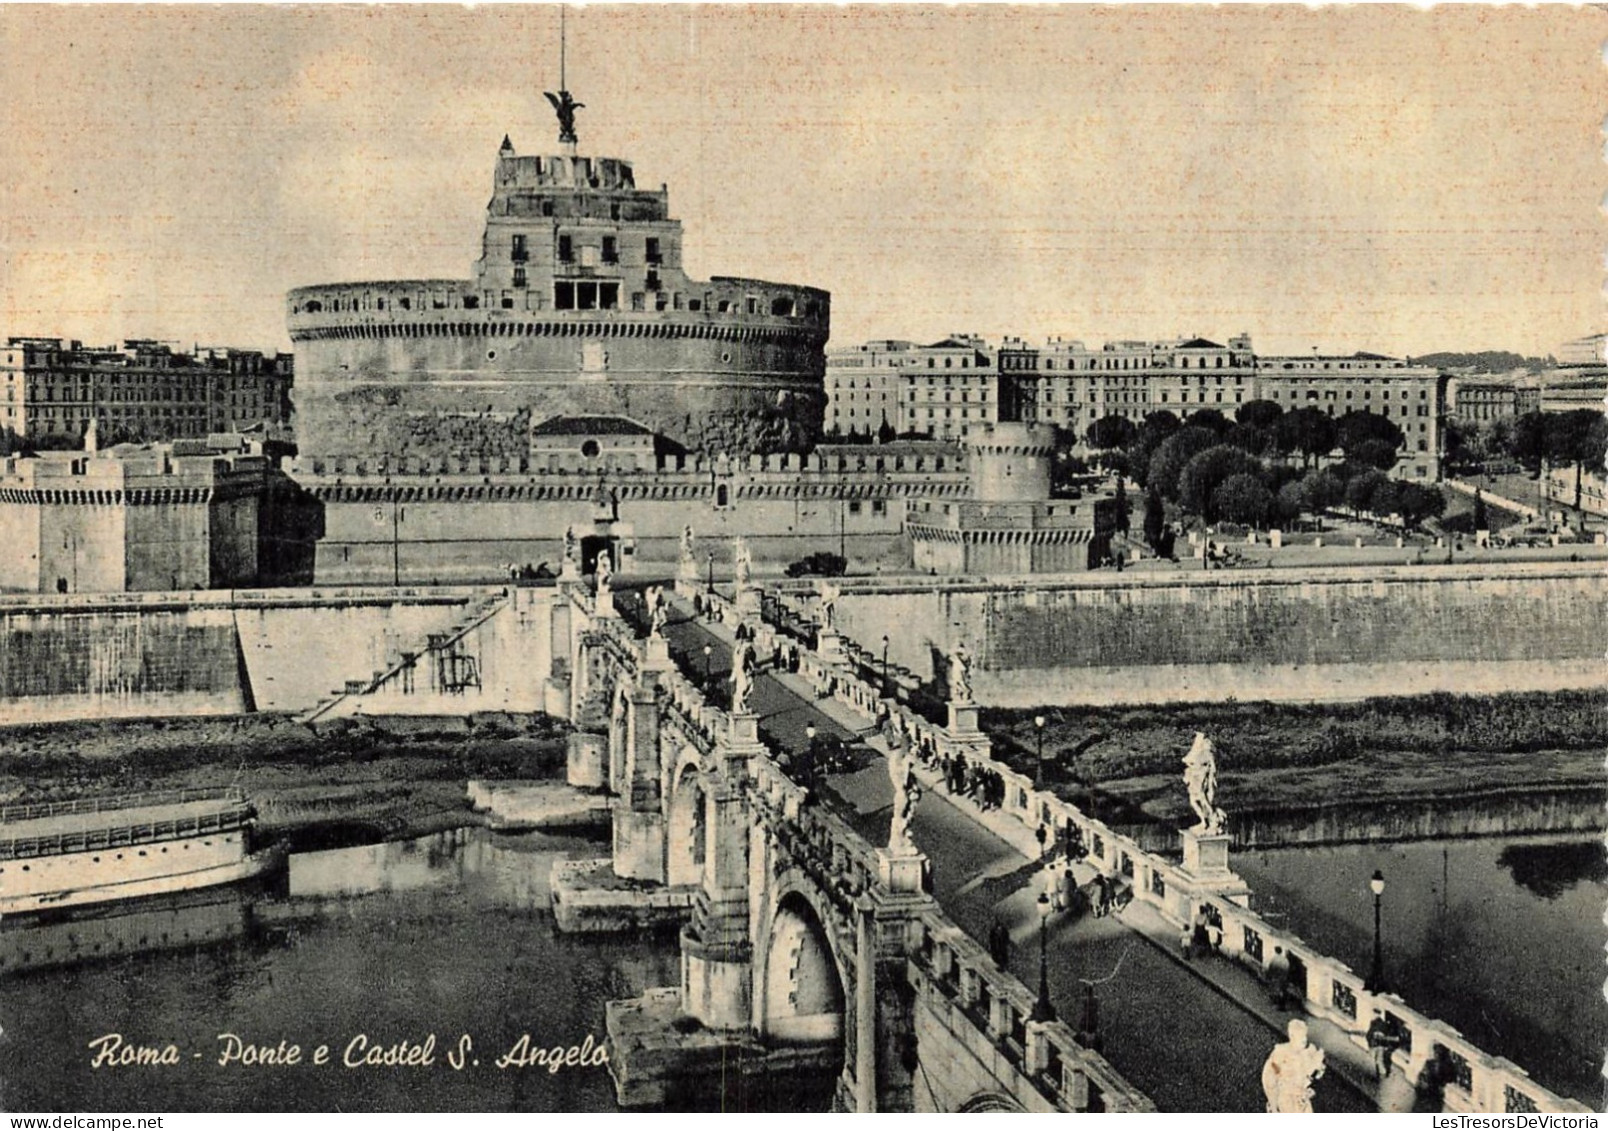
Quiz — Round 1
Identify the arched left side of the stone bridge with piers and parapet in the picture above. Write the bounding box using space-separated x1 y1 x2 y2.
553 586 1153 1112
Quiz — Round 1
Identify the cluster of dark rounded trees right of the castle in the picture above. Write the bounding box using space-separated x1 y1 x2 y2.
1087 401 1446 540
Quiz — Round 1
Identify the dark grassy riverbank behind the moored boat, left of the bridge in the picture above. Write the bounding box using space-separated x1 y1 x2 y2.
0 714 566 843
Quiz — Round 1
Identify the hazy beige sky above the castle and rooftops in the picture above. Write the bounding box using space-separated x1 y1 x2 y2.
0 5 1608 354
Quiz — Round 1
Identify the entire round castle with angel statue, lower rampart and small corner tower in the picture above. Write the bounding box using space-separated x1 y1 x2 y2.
276 79 1113 582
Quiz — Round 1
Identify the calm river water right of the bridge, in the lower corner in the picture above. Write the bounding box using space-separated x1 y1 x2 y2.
1232 835 1608 1110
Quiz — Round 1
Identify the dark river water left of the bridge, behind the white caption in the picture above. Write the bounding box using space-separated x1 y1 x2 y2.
0 829 680 1112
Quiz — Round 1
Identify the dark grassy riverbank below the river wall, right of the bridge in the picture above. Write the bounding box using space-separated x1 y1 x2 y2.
982 692 1608 824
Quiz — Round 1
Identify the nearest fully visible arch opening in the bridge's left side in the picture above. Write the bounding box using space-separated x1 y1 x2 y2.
754 878 852 1044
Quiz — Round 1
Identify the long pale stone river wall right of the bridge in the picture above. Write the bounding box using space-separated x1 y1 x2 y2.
838 563 1608 706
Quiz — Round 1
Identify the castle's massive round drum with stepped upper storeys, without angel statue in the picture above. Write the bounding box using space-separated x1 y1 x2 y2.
286 133 830 473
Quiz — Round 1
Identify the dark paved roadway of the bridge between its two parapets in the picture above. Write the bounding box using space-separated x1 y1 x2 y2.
646 602 1378 1112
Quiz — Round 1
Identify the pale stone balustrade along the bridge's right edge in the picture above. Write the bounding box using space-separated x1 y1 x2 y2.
765 584 1590 1113
